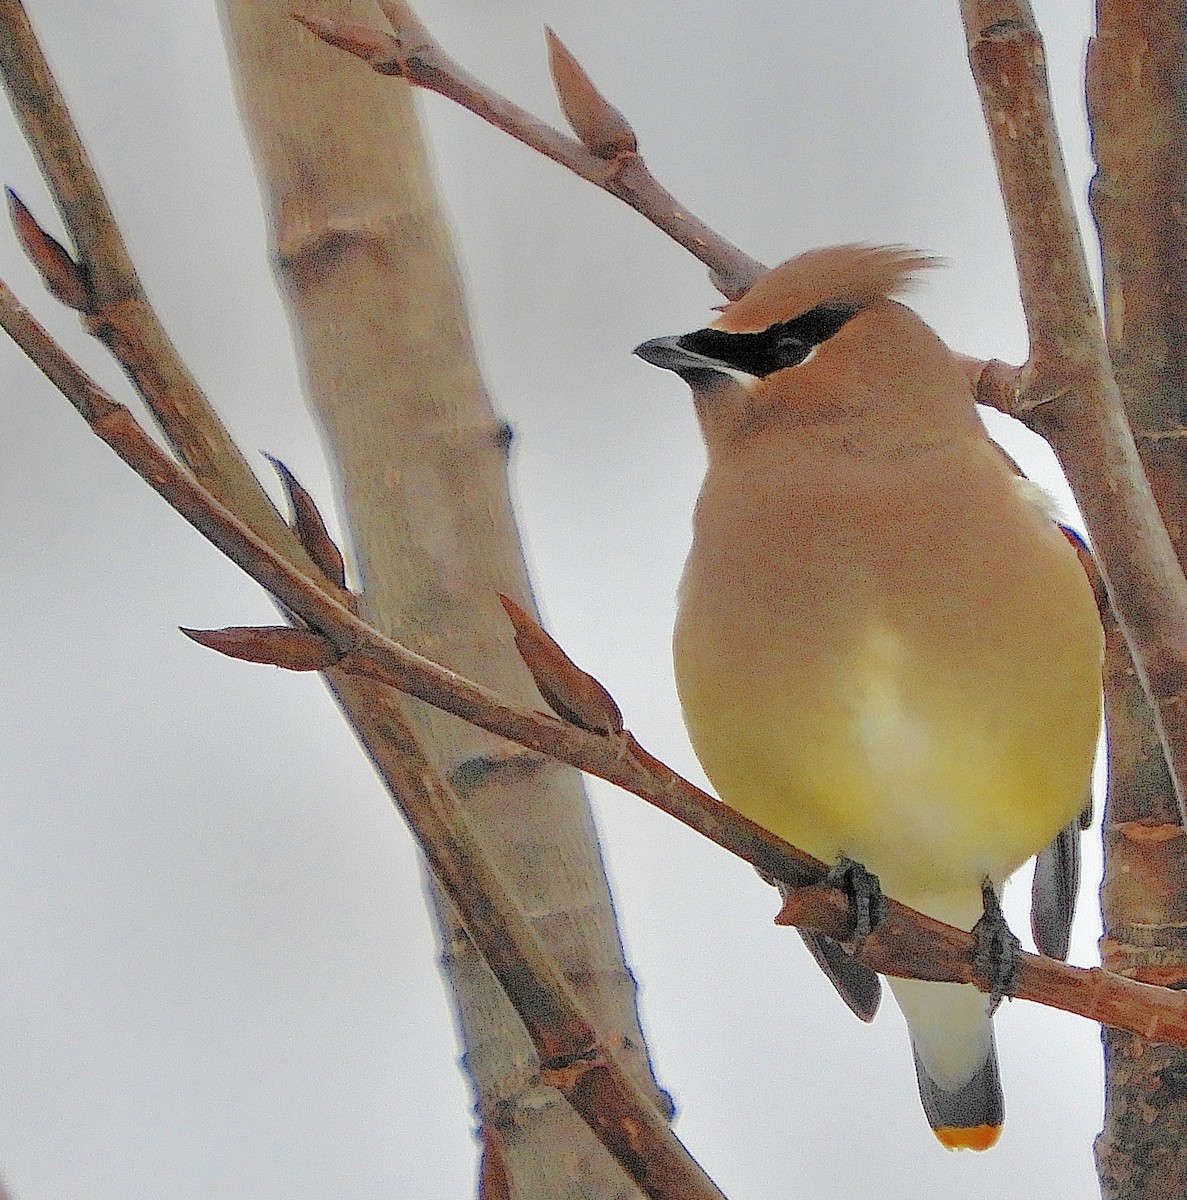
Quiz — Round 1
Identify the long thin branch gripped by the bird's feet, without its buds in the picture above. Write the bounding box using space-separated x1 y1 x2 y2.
0 276 1187 1056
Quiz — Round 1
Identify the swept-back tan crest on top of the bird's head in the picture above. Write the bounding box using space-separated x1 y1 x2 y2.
712 245 940 334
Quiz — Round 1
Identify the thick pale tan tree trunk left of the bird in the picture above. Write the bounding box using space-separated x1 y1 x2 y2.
216 0 658 1200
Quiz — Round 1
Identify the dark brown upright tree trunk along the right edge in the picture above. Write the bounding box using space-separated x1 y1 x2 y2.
1087 0 1187 1200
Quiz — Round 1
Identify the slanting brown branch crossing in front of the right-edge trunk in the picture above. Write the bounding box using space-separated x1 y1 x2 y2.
961 0 1187 825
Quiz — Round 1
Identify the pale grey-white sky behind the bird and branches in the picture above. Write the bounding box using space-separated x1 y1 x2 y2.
0 0 1102 1200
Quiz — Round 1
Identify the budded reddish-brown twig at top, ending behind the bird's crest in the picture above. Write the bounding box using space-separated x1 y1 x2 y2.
294 0 765 298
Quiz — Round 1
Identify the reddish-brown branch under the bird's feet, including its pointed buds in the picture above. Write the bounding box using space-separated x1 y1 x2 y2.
9 4 1187 1060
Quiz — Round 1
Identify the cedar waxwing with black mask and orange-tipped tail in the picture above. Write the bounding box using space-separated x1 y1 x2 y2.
636 246 1102 1150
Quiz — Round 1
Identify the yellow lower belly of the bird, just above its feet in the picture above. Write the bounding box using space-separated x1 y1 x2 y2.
677 592 1099 908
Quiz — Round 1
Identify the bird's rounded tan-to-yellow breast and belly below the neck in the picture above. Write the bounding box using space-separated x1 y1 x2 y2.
675 441 1101 898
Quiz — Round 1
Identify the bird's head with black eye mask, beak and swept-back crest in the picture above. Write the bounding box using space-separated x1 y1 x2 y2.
635 246 963 449
